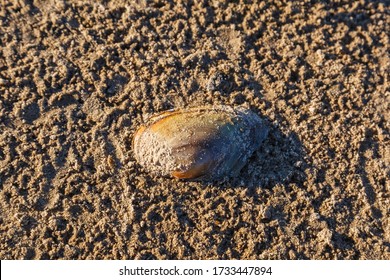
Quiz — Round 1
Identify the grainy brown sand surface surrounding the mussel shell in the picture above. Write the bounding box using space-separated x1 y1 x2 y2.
0 0 390 259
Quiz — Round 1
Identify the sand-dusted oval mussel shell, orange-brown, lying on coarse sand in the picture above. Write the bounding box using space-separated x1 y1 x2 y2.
133 106 268 180
